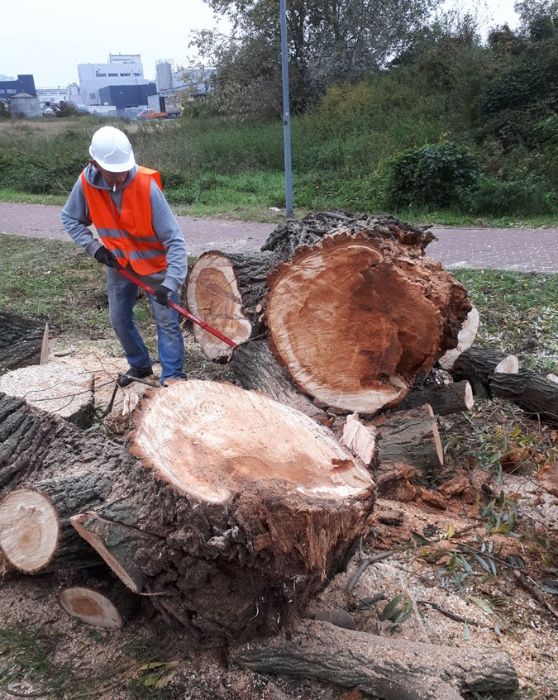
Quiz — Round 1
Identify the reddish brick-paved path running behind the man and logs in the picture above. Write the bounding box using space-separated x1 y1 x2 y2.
0 202 558 272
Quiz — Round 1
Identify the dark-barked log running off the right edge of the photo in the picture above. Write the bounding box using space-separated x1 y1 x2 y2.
490 371 558 424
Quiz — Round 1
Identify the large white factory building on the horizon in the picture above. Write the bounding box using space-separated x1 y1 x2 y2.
78 53 149 105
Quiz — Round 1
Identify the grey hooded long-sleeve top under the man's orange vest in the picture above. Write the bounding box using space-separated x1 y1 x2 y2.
61 163 187 291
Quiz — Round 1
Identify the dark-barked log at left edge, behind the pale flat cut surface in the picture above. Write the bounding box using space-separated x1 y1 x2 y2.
0 312 45 374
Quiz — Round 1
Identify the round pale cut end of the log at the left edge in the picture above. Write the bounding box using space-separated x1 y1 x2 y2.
0 489 60 574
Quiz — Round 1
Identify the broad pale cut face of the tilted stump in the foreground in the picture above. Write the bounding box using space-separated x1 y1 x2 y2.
131 381 369 503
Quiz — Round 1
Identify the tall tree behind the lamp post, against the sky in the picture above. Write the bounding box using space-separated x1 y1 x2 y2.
193 0 439 117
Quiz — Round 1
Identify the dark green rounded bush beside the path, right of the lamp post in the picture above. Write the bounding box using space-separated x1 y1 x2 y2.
388 142 479 209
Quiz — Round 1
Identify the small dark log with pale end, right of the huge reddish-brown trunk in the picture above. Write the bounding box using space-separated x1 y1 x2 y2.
451 346 519 399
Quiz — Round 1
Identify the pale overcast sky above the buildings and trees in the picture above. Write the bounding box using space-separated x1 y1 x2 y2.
0 0 516 87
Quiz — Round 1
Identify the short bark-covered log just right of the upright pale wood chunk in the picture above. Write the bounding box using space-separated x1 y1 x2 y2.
375 404 444 476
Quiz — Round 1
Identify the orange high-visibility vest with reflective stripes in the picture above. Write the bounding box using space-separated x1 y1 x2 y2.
81 165 167 275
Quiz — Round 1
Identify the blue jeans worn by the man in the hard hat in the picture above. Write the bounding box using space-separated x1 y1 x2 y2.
107 266 186 383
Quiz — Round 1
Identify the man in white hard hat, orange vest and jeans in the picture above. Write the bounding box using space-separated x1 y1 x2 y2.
61 126 187 385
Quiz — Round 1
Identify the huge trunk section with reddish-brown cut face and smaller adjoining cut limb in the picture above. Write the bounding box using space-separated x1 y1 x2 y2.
187 216 471 413
